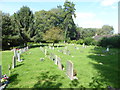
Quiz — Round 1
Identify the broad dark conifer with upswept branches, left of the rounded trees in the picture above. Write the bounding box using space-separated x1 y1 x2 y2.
14 6 34 45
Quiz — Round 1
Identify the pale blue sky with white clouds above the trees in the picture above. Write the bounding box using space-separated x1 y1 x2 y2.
0 0 119 33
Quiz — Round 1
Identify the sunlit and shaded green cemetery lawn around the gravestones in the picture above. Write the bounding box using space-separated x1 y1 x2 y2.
2 44 120 88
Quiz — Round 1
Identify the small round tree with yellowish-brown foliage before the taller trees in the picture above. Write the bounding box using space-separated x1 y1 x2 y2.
43 27 63 46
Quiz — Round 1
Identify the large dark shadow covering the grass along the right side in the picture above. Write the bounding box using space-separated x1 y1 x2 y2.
88 47 120 88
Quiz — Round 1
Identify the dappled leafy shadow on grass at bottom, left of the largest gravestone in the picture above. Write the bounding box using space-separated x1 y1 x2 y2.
34 72 62 88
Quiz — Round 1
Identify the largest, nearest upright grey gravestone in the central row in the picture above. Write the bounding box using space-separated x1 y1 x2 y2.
66 61 73 80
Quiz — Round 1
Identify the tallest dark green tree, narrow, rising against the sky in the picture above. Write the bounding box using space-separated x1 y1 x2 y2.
63 0 76 39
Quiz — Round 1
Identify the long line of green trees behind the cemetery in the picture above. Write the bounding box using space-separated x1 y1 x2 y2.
2 1 113 49
